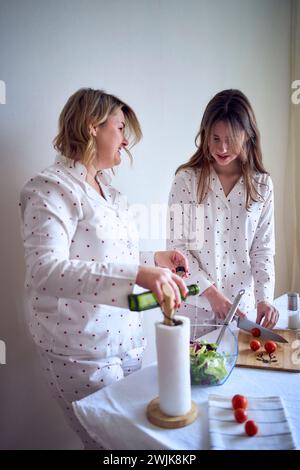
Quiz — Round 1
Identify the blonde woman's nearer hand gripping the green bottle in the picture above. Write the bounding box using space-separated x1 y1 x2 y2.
136 266 188 308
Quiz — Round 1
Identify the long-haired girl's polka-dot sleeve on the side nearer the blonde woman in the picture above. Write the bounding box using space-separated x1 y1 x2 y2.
167 171 214 294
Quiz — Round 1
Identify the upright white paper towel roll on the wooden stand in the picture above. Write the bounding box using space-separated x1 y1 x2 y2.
155 316 192 416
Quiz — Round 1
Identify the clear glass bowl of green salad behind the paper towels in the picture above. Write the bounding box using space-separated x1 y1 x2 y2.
190 324 238 386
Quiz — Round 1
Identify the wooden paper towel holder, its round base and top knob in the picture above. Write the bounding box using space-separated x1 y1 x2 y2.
147 284 198 429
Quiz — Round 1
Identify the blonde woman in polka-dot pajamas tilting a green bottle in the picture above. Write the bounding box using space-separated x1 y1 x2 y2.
21 89 188 447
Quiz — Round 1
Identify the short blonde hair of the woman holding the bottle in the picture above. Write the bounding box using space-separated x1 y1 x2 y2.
53 88 142 165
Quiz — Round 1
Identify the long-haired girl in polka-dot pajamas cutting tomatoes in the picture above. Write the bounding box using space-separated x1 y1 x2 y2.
168 90 279 328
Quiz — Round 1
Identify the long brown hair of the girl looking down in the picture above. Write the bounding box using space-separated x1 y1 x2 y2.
176 90 268 210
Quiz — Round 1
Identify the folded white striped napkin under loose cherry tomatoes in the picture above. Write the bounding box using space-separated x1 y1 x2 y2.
208 395 296 450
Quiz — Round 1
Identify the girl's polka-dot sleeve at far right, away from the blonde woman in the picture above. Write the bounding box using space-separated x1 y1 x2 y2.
250 178 275 304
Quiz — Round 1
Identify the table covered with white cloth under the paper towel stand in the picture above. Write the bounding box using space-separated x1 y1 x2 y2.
73 296 300 450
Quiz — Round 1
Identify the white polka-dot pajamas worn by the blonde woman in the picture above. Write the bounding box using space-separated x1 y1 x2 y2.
20 157 153 448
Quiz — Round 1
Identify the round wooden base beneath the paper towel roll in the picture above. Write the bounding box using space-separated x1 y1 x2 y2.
147 398 198 429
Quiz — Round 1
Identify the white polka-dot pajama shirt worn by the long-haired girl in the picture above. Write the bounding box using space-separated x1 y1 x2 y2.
167 168 275 319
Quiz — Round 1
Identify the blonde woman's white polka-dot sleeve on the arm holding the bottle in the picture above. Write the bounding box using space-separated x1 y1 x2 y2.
20 175 138 308
